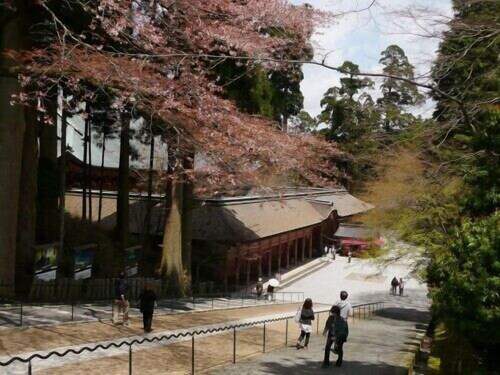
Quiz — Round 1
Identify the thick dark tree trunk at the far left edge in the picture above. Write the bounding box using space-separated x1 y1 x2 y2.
0 4 31 295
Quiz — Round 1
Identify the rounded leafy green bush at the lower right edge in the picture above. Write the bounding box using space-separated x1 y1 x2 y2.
428 213 500 344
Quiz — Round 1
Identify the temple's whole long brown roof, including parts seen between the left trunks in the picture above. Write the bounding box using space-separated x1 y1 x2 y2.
66 190 373 242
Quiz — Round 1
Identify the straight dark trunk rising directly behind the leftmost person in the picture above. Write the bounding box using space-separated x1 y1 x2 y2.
116 116 130 250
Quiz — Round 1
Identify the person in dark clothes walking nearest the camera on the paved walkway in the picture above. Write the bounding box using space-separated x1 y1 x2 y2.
322 306 348 367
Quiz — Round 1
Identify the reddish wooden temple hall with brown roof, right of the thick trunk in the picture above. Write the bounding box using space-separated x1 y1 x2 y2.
193 189 373 288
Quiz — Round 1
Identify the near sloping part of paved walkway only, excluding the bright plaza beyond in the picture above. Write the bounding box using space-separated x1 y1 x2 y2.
209 308 429 375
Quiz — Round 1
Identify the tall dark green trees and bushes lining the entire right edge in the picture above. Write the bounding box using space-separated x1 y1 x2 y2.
428 0 500 369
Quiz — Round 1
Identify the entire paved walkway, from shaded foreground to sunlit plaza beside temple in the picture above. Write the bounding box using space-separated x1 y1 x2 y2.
210 256 430 375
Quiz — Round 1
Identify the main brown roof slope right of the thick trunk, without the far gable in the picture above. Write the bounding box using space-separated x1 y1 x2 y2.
193 198 333 242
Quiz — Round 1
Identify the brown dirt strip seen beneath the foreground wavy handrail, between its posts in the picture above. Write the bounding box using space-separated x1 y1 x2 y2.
36 312 334 375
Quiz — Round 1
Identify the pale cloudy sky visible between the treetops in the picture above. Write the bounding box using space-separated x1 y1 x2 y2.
290 0 452 117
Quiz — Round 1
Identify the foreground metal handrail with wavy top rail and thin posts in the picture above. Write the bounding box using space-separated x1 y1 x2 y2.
0 302 384 373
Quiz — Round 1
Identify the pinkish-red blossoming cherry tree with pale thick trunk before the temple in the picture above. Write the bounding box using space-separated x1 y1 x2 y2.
0 0 338 294
